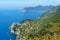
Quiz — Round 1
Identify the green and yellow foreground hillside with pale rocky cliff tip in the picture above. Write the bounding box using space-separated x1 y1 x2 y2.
11 6 60 40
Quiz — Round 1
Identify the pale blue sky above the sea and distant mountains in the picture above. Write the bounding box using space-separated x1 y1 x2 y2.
0 0 60 9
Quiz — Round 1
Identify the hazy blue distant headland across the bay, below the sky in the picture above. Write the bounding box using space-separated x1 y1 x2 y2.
21 6 54 12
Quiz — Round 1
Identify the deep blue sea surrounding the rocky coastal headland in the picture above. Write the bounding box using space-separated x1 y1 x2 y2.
0 10 43 40
